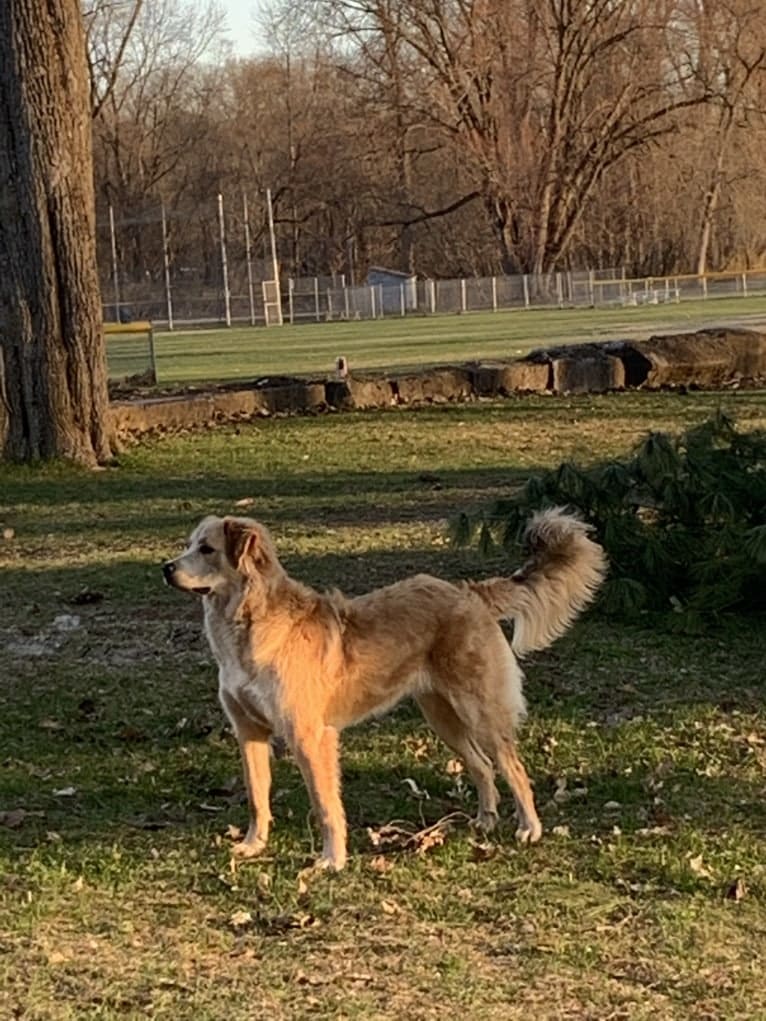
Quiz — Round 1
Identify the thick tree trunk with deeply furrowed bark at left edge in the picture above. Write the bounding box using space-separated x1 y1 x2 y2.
0 0 110 464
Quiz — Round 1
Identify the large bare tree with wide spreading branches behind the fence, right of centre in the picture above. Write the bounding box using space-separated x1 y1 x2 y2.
315 0 709 273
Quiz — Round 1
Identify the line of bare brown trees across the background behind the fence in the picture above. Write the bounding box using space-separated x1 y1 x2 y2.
85 0 766 280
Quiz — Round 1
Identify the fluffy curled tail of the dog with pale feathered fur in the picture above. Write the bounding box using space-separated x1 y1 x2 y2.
470 507 607 655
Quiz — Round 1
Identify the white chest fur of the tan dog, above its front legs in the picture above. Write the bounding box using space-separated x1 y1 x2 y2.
204 599 282 733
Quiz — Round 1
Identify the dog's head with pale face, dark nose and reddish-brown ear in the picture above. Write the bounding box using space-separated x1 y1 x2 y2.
162 517 281 595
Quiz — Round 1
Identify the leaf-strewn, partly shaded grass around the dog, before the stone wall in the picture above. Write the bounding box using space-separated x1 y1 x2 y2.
0 392 766 1021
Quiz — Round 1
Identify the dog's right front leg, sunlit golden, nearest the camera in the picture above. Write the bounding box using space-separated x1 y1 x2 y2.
292 727 346 871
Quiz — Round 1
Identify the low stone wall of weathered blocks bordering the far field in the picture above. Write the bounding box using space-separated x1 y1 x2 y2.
111 330 766 437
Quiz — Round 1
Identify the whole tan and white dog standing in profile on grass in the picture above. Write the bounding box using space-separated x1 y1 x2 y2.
162 508 606 870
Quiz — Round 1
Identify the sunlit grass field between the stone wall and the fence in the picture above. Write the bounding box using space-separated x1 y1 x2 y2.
108 297 766 386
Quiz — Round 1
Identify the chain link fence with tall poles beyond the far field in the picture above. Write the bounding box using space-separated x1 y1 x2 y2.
98 196 766 330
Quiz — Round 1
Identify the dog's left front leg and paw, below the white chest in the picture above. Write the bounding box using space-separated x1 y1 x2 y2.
221 690 272 858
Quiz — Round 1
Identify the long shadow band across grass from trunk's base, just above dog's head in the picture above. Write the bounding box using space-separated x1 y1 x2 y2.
3 468 535 542
